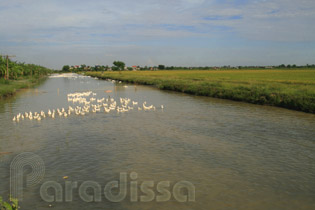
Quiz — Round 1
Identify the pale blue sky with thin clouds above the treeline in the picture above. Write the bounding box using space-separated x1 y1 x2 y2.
0 0 315 69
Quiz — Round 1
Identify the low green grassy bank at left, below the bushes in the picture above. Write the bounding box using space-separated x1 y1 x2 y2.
0 76 47 100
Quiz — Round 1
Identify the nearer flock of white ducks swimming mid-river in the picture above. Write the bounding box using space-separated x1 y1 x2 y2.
12 91 164 122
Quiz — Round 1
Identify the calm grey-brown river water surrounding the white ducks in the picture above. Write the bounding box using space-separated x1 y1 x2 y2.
0 75 315 210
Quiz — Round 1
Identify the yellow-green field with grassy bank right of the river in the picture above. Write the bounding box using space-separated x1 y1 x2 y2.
86 69 315 113
